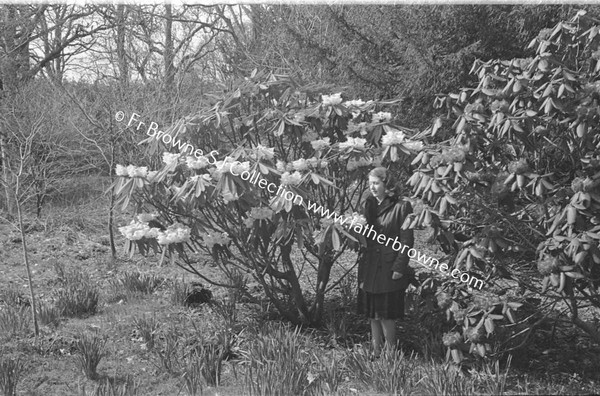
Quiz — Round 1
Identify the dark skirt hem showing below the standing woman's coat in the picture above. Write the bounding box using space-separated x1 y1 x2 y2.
357 288 406 320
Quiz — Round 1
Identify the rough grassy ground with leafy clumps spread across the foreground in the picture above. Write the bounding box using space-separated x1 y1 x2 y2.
0 184 598 396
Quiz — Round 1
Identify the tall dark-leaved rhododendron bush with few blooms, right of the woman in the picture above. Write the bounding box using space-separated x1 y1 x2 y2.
409 11 600 361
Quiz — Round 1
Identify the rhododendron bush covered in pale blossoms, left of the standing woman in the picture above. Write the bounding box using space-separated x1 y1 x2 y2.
114 73 422 323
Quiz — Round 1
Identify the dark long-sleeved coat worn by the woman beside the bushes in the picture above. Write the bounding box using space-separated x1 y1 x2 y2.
358 196 414 293
